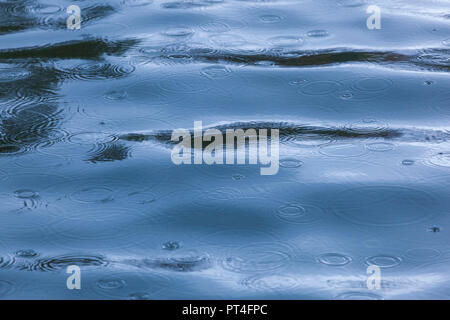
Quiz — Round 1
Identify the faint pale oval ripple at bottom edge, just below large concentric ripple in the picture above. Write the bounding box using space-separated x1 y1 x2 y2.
240 274 302 293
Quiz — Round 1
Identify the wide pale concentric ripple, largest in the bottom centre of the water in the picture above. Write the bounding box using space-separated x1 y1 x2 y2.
222 242 292 273
